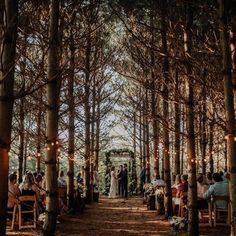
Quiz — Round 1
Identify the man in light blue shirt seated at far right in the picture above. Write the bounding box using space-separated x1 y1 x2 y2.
203 173 229 209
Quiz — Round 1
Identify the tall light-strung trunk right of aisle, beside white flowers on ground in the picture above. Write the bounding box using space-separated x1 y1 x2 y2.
184 0 199 236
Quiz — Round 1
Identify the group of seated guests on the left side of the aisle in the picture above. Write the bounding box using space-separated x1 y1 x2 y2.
7 167 98 224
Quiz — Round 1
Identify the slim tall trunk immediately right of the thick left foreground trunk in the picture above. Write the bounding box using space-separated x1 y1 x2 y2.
67 26 75 209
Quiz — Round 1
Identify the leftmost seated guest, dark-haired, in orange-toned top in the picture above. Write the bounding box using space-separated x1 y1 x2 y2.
7 174 20 209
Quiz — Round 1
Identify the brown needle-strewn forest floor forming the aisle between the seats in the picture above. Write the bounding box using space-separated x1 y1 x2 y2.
7 197 229 236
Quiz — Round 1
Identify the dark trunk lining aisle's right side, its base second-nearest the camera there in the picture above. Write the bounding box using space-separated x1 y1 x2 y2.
161 0 173 216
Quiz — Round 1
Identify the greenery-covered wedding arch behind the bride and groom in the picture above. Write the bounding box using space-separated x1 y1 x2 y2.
104 148 137 195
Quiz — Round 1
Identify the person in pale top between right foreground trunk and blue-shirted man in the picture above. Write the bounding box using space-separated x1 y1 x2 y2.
197 175 208 210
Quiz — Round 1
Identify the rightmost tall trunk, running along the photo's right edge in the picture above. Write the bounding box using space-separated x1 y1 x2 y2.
219 0 236 236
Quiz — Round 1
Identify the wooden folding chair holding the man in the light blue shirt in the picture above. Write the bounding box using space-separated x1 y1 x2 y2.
212 196 231 227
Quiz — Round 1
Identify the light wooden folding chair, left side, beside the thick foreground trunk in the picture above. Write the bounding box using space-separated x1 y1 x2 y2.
18 195 37 229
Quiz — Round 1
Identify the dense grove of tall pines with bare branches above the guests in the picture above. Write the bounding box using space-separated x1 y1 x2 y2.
0 0 236 235
